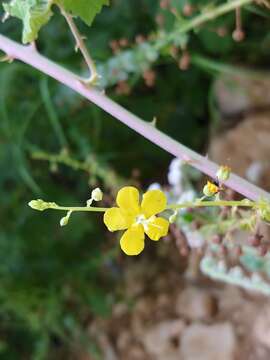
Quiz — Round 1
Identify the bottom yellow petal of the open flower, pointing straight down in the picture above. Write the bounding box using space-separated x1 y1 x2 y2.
120 225 144 255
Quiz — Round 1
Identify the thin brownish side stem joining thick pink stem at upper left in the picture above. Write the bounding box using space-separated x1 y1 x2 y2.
60 7 98 84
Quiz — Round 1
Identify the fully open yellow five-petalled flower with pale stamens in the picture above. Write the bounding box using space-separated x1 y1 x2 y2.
104 186 169 255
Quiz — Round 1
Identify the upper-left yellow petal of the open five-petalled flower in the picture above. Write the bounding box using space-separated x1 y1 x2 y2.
116 186 140 214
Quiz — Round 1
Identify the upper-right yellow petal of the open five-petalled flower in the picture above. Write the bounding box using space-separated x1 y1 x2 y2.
141 190 167 218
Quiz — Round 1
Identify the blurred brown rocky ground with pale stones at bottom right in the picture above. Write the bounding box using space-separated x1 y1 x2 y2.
89 248 270 360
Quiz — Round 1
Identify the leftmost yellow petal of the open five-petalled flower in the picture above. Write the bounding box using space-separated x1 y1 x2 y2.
103 207 134 231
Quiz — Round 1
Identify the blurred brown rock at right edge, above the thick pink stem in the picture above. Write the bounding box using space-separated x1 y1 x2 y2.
208 112 270 190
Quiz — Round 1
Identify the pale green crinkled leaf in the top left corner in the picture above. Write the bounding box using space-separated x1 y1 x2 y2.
3 0 52 43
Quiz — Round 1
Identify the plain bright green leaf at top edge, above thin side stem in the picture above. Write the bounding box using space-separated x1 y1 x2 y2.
60 0 109 25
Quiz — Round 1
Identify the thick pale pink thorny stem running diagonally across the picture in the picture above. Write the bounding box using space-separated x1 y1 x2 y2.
0 35 270 201
